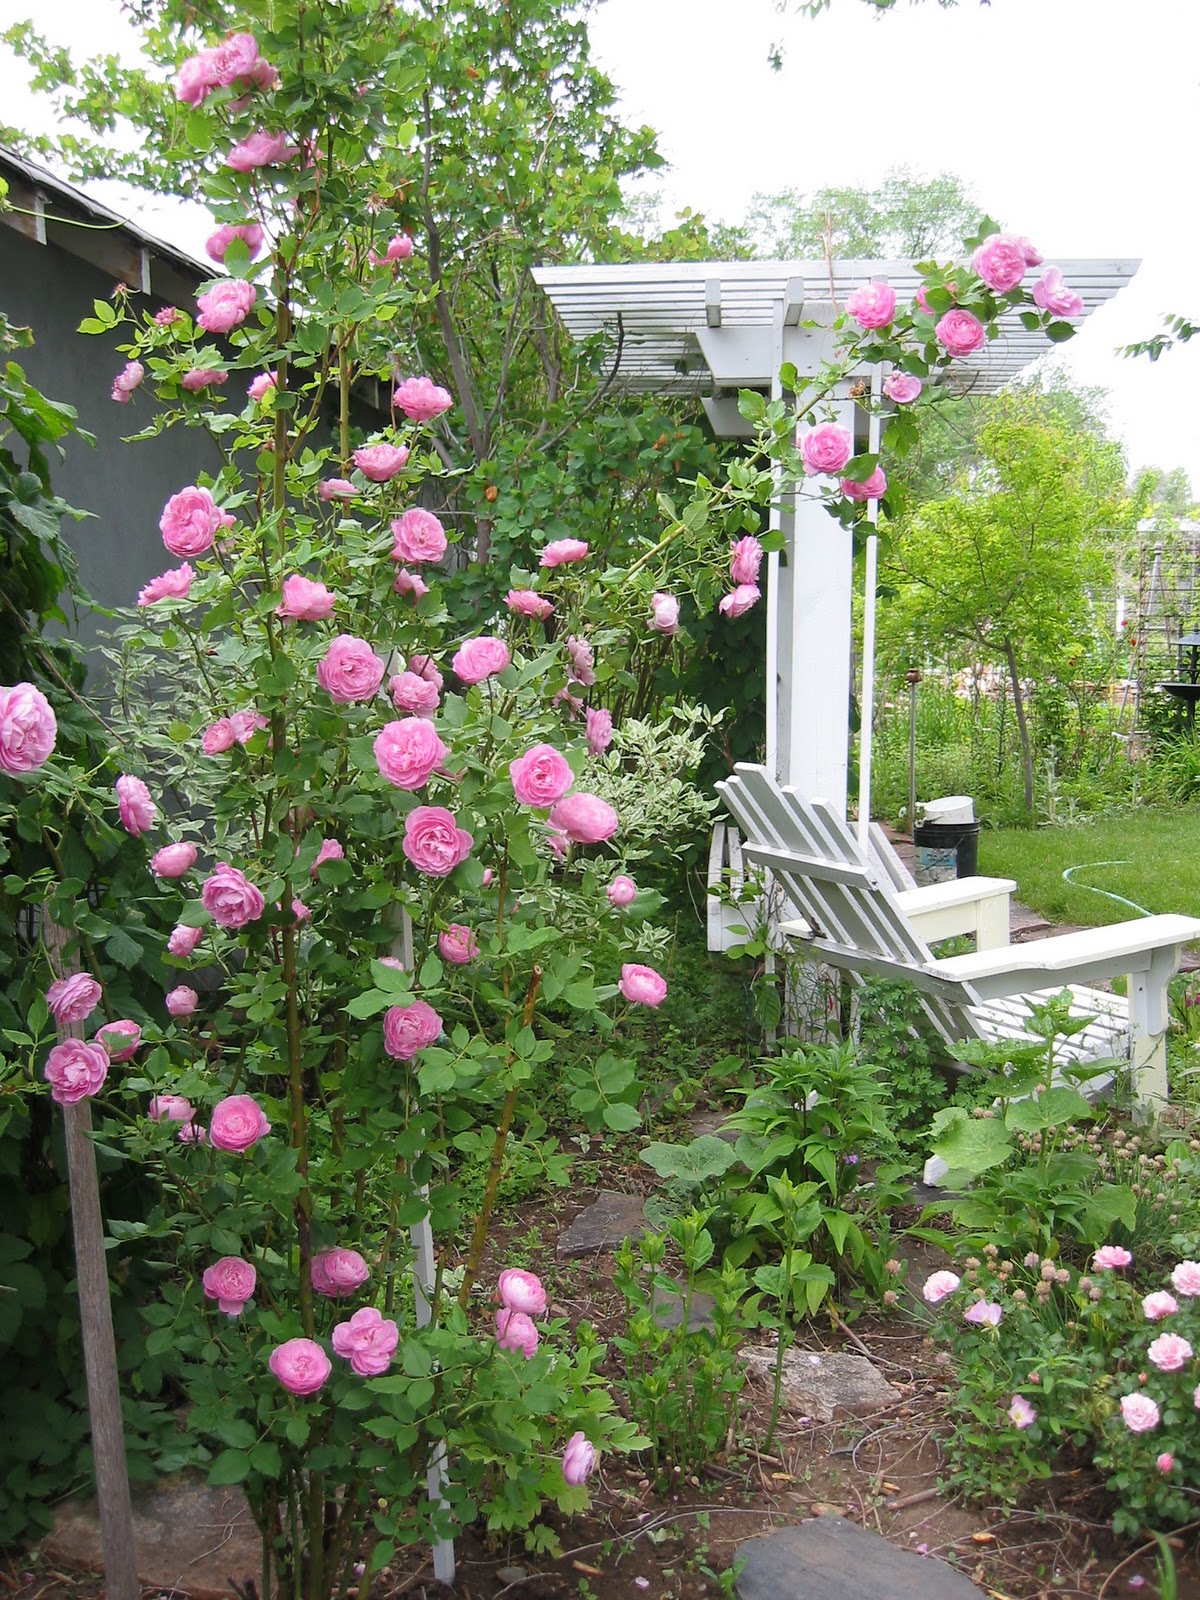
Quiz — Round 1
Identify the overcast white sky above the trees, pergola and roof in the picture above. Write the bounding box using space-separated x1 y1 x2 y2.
0 0 1200 493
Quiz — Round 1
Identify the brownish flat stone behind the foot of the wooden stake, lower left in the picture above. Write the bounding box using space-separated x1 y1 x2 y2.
43 1477 262 1600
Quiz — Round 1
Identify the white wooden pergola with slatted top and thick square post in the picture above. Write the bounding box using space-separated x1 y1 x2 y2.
534 258 1141 826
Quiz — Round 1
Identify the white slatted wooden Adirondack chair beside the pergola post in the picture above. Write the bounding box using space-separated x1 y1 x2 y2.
717 763 1200 1112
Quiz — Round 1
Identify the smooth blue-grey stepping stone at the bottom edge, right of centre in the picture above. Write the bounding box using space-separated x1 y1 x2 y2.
734 1517 979 1600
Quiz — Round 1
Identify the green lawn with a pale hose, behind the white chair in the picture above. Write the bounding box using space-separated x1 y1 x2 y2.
979 806 1200 925
